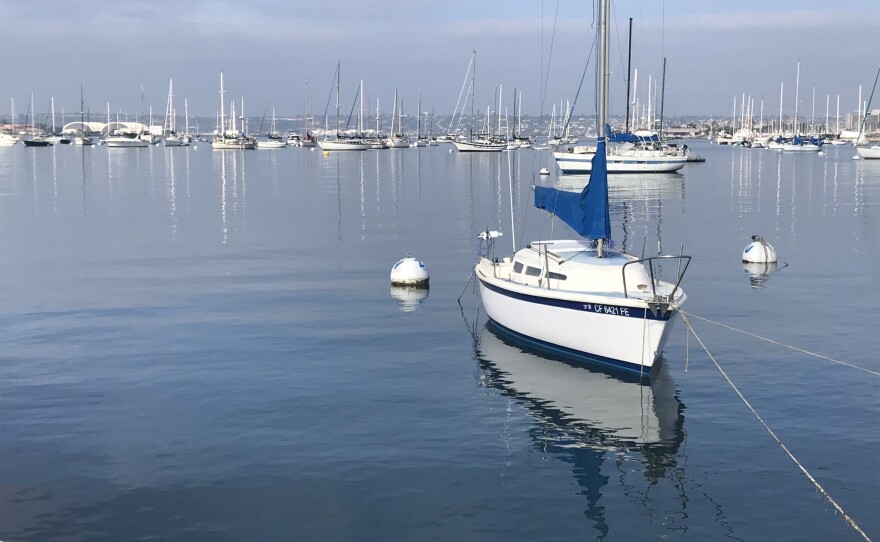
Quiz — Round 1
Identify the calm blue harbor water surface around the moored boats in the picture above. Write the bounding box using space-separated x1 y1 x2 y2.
0 142 880 542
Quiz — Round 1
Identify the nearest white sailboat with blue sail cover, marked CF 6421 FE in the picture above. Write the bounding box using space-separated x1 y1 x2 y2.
474 0 691 375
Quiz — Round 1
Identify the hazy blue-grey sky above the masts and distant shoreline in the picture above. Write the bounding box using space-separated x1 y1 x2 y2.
0 0 880 122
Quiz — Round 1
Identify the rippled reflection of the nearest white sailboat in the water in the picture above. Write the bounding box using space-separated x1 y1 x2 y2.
476 321 687 538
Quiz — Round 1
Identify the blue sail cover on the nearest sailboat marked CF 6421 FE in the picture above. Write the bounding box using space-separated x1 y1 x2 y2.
535 138 611 239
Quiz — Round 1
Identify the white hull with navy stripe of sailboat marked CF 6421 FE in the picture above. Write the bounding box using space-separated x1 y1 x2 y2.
475 249 687 375
